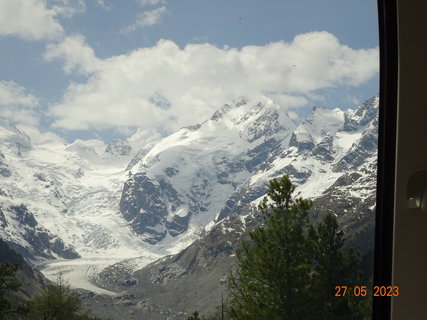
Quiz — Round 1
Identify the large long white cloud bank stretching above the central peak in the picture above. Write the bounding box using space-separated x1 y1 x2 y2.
46 32 378 131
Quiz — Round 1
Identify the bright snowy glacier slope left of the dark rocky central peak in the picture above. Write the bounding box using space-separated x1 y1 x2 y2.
0 121 150 260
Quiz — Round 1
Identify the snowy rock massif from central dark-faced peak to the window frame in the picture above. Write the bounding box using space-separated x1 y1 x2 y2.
120 98 378 244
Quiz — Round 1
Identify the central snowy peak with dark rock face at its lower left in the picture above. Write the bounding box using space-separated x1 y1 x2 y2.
120 99 295 243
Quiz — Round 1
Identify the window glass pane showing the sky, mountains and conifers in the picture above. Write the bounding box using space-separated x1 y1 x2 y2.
0 0 382 319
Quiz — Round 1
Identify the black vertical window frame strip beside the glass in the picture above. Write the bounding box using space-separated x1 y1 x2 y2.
372 0 398 320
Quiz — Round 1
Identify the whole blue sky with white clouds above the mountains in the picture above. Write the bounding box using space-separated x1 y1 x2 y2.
0 0 378 141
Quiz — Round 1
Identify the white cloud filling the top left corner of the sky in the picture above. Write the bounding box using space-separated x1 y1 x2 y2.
0 0 63 40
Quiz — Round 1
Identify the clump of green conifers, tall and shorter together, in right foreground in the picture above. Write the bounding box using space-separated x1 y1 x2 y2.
228 176 369 320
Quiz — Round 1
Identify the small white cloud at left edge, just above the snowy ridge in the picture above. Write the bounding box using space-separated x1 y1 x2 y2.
0 81 38 124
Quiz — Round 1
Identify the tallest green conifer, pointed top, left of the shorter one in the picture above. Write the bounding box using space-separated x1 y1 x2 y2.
228 176 312 320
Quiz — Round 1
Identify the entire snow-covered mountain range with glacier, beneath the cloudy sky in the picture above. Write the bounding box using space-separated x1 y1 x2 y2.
0 97 378 319
